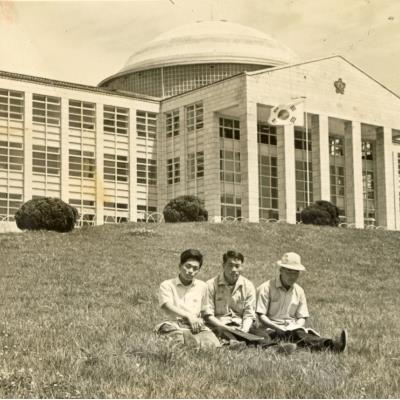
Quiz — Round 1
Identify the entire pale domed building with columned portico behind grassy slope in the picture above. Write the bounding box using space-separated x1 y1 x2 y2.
0 21 400 230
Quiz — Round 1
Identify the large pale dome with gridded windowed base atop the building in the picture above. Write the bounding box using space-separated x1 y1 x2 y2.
99 21 297 98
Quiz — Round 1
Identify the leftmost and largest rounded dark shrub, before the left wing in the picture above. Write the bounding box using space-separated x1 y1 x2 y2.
15 197 79 232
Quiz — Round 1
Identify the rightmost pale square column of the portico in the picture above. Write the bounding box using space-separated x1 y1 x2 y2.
375 127 395 229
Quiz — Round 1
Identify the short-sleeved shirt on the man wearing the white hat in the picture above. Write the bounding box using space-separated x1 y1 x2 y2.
256 276 310 325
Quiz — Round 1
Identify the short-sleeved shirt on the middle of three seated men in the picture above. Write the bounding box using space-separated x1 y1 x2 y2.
204 274 256 325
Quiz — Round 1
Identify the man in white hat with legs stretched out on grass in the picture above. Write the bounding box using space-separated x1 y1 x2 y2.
256 252 347 353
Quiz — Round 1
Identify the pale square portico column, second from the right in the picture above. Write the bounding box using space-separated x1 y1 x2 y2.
344 121 364 228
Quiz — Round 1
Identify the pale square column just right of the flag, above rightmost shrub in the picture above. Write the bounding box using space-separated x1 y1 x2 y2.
311 115 331 201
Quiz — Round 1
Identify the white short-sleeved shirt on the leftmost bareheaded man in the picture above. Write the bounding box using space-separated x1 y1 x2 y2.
158 277 207 318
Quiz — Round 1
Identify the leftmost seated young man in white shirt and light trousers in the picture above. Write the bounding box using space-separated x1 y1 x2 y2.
156 249 220 347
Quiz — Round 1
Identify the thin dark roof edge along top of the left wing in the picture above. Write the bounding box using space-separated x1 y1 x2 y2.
0 70 161 103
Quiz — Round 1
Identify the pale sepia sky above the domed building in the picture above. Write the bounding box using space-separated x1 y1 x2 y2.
0 0 400 94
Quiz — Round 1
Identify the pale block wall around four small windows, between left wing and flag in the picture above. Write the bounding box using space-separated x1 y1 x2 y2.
158 75 246 220
